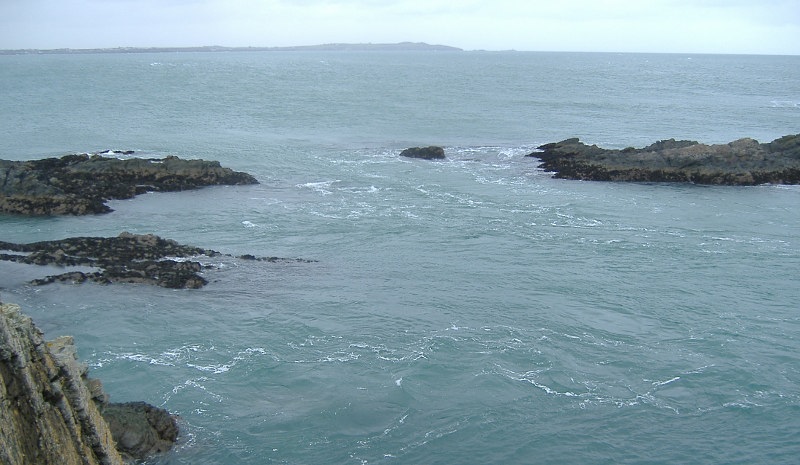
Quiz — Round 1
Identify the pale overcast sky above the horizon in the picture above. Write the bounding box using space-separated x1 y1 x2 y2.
0 0 800 55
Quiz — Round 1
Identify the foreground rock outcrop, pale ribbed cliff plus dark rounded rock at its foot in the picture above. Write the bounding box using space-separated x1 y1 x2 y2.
0 303 178 465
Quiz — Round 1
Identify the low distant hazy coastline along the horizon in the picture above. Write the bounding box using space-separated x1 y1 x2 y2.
0 42 463 55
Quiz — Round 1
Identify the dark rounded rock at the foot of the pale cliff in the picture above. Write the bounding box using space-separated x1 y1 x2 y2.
102 402 178 460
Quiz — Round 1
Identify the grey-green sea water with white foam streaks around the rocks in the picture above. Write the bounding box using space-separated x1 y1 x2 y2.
0 52 800 465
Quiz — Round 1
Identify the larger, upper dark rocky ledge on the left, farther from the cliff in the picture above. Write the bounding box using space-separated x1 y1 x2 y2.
0 151 258 215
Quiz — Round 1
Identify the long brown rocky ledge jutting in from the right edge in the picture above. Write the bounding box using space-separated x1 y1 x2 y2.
528 134 800 185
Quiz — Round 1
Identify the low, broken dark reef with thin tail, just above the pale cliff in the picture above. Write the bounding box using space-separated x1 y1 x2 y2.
0 232 310 289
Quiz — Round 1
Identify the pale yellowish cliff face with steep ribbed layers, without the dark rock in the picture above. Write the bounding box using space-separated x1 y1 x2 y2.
0 304 123 465
